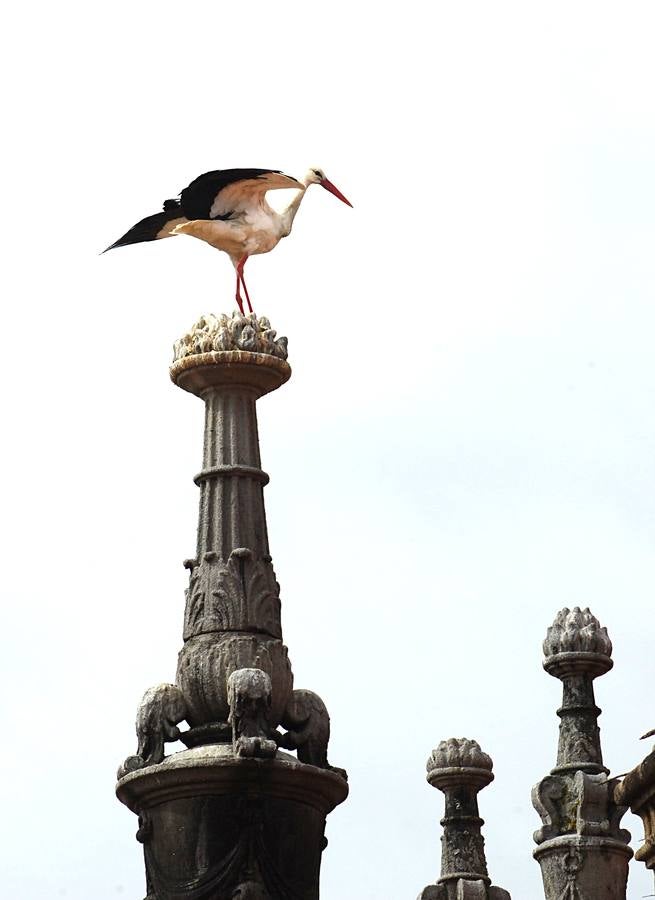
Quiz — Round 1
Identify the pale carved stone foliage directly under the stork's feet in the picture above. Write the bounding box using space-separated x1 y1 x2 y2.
173 312 288 362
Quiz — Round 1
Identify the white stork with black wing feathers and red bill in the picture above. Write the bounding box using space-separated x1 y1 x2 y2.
104 169 352 313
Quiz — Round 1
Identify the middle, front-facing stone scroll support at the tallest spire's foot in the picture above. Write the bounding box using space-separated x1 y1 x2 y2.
227 669 277 758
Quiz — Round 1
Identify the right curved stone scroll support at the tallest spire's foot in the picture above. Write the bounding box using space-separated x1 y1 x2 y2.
278 691 348 780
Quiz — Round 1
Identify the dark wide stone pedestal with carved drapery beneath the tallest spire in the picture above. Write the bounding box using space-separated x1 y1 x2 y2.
116 744 348 900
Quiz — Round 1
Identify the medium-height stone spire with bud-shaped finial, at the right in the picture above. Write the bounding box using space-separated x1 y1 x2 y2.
532 607 632 900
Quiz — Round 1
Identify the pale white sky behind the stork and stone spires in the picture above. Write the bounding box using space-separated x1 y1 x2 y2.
0 0 655 900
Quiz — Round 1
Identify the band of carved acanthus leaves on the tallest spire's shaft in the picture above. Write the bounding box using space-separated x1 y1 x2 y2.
184 548 282 640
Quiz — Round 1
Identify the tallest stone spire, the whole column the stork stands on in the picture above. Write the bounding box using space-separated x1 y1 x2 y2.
117 314 348 900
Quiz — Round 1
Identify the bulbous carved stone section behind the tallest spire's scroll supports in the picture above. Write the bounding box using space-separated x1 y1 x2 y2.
176 632 293 728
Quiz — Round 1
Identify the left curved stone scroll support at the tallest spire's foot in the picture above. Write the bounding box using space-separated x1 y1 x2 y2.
118 684 186 778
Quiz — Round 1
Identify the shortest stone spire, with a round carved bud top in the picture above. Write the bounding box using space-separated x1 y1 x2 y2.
418 738 510 900
